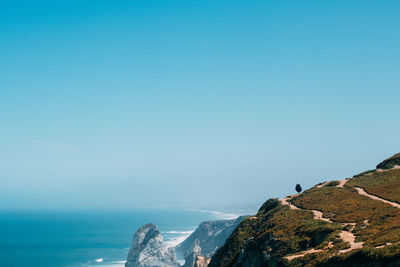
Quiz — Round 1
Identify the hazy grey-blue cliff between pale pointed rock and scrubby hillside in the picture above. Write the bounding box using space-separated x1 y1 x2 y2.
175 216 246 266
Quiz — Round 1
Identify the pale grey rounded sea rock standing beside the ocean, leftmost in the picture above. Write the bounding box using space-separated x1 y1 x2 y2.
125 223 180 267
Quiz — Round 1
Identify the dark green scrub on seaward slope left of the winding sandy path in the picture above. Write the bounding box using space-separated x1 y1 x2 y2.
209 199 347 267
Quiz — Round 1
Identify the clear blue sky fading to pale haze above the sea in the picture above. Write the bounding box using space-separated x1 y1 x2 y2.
0 0 400 209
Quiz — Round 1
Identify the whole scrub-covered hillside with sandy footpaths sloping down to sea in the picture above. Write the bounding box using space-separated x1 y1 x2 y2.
209 154 400 267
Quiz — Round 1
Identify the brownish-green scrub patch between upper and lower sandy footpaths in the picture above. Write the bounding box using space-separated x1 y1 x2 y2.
292 187 400 247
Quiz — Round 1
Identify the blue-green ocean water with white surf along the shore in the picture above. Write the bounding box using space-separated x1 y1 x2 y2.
0 209 234 267
